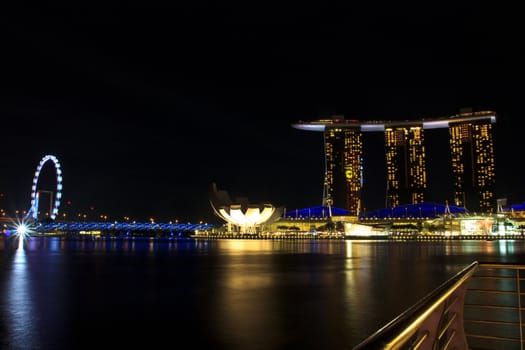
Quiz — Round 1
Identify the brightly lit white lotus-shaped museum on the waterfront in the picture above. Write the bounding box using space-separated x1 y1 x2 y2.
210 183 282 233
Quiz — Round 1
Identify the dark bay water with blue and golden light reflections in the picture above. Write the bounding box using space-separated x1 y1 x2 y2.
0 237 525 350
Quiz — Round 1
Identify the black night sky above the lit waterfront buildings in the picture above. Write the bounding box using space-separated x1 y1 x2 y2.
0 1 525 223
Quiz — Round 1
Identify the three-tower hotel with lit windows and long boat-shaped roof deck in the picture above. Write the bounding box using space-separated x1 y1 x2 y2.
292 110 496 216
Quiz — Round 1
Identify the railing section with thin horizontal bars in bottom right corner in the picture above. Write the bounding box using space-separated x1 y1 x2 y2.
464 263 525 350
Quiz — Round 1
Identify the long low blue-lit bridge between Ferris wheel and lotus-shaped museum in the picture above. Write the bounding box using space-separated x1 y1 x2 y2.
30 222 213 234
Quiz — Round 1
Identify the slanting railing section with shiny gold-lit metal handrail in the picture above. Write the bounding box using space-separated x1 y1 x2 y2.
353 261 478 350
